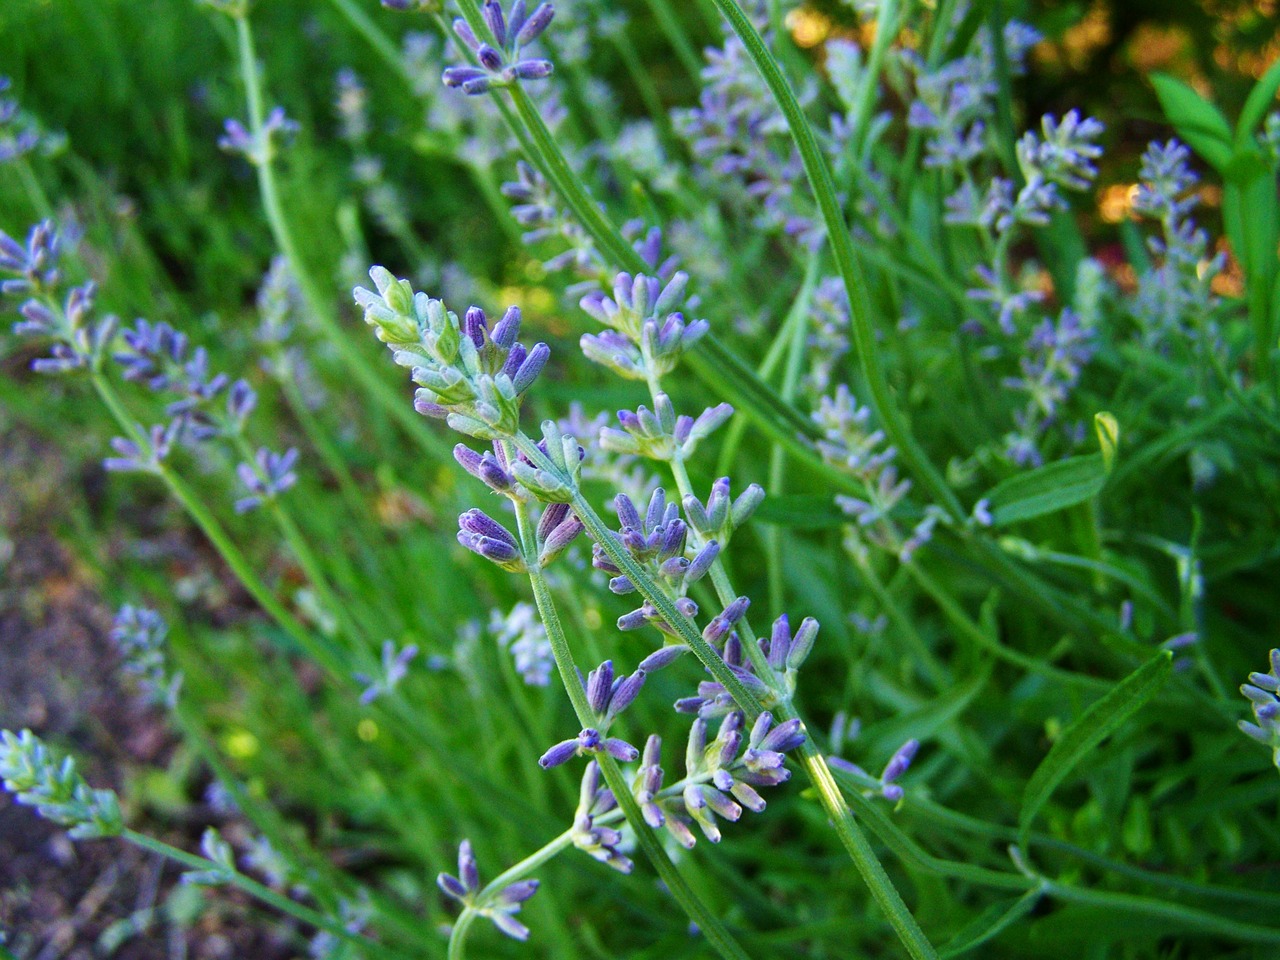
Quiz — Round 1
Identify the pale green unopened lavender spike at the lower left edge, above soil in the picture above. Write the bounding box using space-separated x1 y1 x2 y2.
0 730 124 840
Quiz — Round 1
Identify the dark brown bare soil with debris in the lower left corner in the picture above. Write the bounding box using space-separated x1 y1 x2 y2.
0 428 293 960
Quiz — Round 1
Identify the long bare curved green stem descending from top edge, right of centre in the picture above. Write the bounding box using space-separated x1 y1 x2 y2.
714 0 964 520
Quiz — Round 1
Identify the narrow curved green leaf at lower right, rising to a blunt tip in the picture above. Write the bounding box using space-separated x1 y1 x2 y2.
1019 650 1174 849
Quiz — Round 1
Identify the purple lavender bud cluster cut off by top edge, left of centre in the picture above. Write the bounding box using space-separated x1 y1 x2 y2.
444 0 556 95
